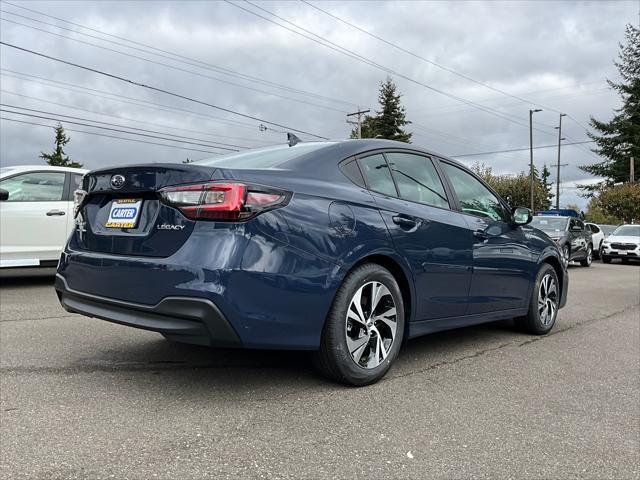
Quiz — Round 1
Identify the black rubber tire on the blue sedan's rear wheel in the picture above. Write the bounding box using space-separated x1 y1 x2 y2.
312 263 404 386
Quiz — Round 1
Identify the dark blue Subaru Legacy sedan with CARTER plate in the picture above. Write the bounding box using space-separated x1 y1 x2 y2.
56 140 568 385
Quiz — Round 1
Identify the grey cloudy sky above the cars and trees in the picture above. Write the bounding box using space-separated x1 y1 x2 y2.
0 0 640 207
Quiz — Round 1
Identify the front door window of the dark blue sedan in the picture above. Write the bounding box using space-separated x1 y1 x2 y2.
442 162 509 222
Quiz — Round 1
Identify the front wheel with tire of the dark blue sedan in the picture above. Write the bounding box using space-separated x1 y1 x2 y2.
515 263 560 335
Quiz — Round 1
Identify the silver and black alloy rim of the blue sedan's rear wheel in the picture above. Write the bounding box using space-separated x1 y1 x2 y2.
345 281 398 369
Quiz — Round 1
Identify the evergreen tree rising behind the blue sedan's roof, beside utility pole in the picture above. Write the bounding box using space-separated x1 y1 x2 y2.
351 77 412 143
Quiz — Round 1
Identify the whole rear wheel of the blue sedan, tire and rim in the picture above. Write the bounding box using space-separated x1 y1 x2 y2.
313 263 404 386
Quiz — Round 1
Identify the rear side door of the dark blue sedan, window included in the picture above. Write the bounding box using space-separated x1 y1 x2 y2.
358 151 472 320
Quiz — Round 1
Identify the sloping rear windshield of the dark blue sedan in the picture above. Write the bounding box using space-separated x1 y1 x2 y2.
193 142 334 169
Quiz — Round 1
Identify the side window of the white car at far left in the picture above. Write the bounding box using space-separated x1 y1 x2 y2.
0 172 65 202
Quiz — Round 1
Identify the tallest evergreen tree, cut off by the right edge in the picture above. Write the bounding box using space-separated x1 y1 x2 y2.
580 25 640 196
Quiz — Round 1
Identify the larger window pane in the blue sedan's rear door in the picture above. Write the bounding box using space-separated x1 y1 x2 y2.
385 152 449 208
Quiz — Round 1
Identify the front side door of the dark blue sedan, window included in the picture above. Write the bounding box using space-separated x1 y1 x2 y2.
441 161 537 314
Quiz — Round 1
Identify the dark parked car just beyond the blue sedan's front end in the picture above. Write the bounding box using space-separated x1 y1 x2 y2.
531 215 593 267
